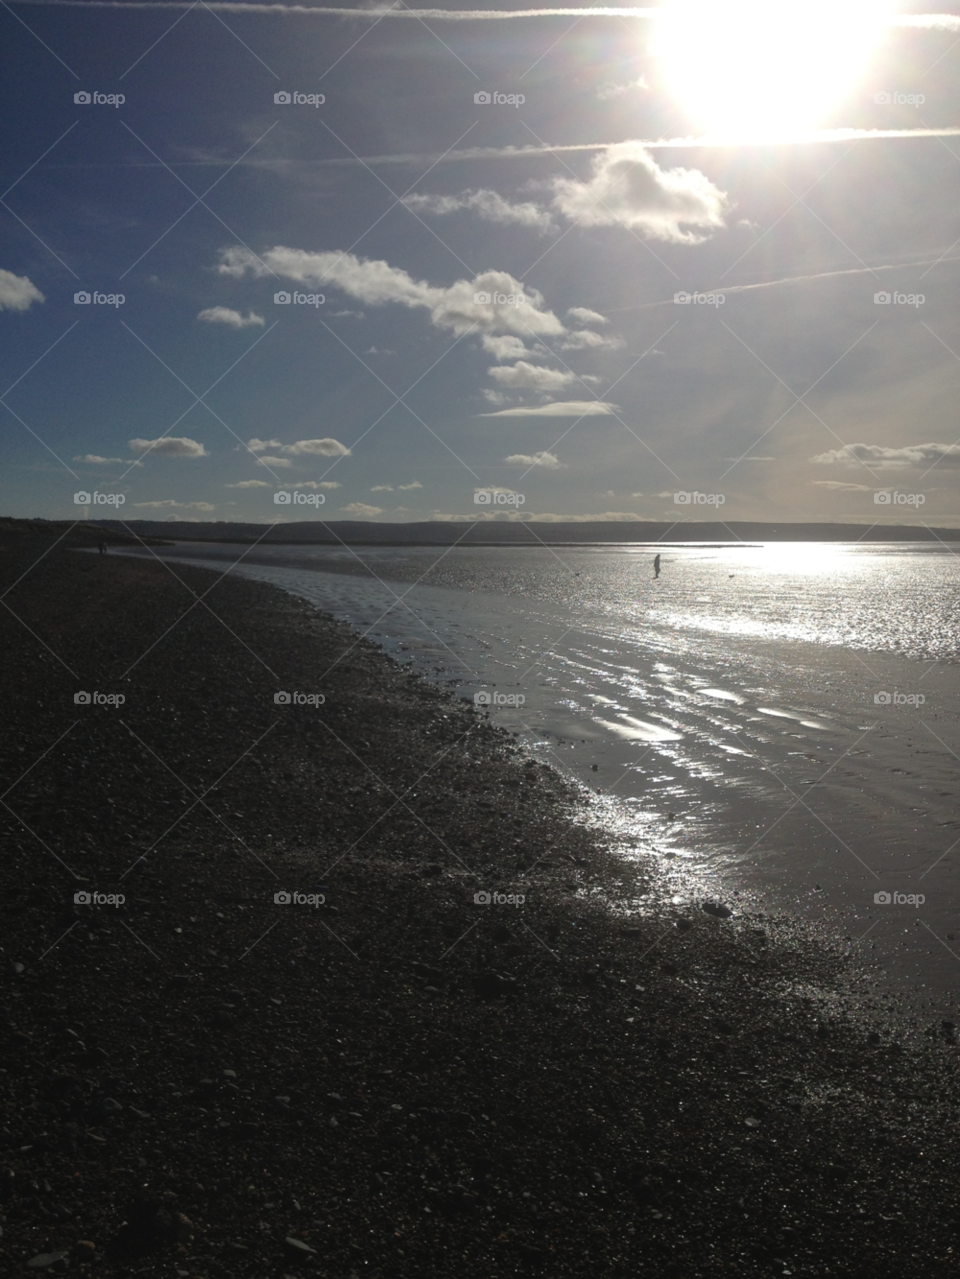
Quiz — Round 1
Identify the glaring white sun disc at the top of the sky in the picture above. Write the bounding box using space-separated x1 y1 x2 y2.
653 0 894 139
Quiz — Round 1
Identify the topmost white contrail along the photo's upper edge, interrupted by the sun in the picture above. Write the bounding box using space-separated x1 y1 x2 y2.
12 0 960 31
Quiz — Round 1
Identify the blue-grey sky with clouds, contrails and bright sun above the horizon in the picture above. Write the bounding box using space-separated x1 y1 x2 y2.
0 0 960 527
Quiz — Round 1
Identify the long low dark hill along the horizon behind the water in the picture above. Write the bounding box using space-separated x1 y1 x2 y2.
90 519 960 546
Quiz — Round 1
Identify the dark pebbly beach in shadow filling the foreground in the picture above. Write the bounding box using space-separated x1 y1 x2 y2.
0 526 960 1279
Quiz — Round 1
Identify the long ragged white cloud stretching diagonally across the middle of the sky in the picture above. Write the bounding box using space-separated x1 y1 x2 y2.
217 246 565 335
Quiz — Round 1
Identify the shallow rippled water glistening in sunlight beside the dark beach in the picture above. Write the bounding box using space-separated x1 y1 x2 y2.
116 544 960 1008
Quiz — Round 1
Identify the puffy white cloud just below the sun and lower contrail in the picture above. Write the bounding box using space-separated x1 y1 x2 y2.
552 142 729 244
